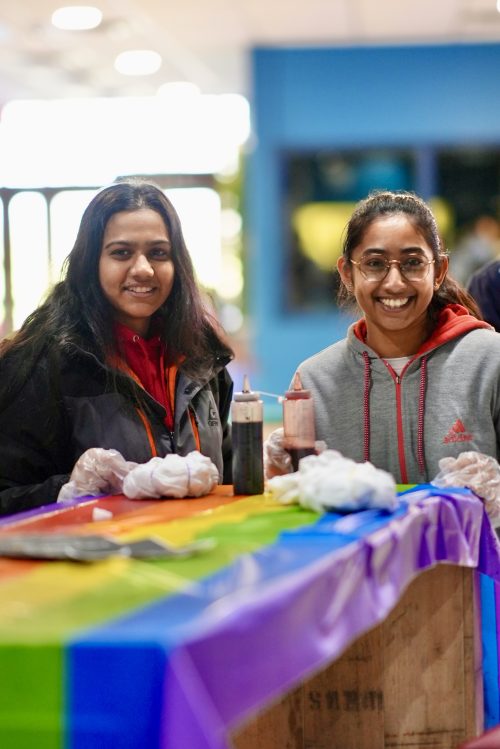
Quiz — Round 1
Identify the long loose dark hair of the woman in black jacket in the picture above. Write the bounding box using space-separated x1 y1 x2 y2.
0 179 232 398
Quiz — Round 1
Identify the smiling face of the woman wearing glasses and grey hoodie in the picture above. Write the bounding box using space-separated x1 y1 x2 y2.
338 213 448 357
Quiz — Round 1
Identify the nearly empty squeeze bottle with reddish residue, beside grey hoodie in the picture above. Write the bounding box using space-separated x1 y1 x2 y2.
283 372 316 471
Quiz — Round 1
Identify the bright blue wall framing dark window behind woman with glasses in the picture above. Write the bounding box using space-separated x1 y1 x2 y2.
249 44 500 406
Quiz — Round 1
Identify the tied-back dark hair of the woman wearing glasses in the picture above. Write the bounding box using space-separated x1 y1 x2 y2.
339 190 482 322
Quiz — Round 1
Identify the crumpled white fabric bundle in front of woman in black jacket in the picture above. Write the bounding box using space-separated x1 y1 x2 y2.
123 450 219 499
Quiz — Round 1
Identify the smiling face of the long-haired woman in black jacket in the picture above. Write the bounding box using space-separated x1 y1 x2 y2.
99 208 175 336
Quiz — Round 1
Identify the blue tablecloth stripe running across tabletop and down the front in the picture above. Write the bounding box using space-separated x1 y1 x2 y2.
67 504 407 749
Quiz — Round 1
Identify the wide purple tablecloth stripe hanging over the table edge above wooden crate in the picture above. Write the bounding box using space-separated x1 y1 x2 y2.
165 495 499 749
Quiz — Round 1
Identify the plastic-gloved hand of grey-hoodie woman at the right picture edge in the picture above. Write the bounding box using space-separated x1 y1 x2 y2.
431 450 500 528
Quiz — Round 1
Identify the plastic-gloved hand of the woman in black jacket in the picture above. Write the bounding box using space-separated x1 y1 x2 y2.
57 447 137 502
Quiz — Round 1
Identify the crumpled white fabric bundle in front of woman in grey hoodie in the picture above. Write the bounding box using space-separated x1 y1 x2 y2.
266 450 398 512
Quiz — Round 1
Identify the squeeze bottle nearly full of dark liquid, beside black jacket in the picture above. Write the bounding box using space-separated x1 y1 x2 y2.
231 375 264 494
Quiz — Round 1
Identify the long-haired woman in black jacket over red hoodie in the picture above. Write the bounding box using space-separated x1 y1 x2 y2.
0 180 232 514
